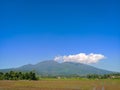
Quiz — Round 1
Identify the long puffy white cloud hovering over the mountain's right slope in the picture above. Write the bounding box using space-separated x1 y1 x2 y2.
54 53 105 64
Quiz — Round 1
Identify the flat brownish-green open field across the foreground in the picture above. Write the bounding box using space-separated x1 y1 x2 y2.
0 79 120 90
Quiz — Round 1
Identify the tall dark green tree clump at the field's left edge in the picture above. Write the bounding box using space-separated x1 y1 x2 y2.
0 71 38 80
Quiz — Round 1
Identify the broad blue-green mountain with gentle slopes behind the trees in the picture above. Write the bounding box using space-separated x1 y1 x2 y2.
0 60 113 76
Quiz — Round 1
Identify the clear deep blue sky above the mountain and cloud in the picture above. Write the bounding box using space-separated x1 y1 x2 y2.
0 0 120 71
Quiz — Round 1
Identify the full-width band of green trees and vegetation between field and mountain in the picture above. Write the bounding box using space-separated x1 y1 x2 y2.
0 71 120 80
